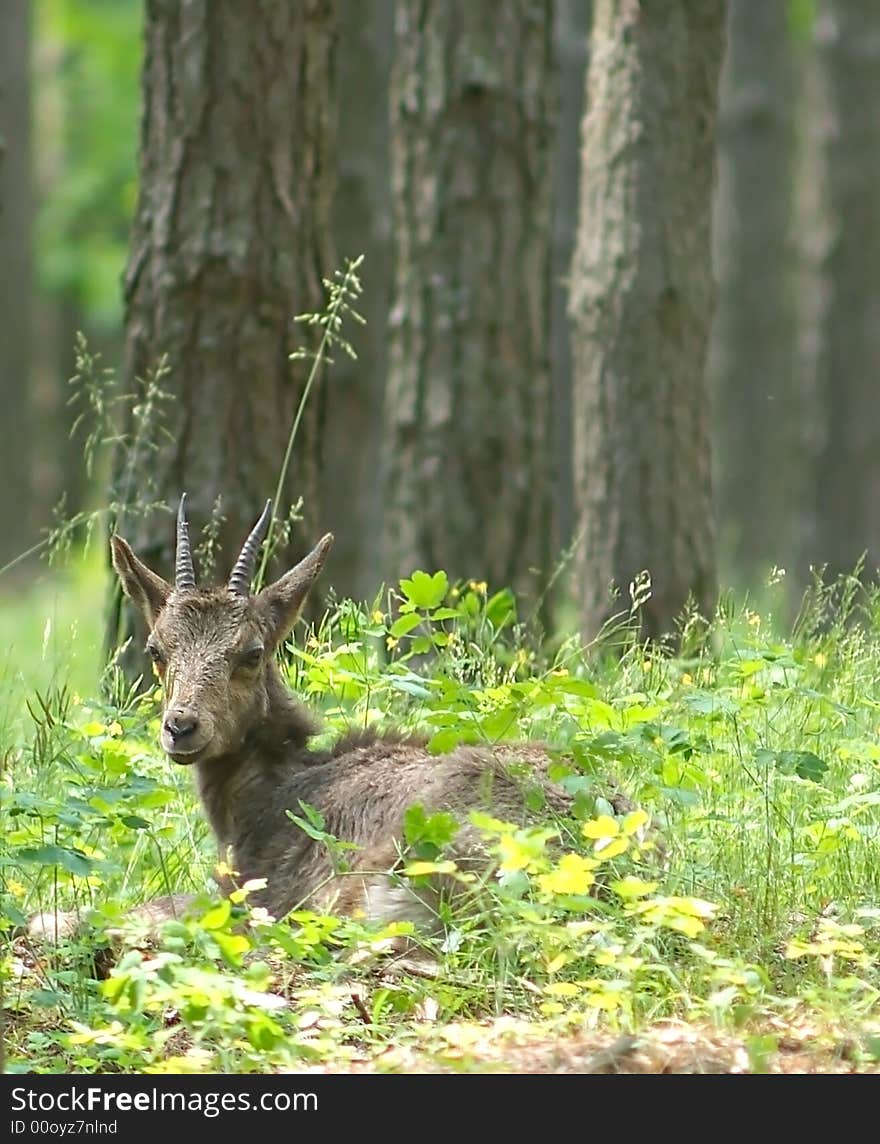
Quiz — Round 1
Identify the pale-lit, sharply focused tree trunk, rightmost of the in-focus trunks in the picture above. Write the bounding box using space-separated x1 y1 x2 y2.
571 0 724 637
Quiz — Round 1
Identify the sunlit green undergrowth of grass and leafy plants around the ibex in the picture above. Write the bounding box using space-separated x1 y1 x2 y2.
0 573 880 1072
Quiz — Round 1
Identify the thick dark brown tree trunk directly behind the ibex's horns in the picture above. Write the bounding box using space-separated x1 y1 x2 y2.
111 0 335 658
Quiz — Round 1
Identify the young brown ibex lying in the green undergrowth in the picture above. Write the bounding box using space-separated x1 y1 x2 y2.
102 494 568 925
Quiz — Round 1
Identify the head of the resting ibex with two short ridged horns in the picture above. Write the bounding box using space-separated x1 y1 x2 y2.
111 493 333 764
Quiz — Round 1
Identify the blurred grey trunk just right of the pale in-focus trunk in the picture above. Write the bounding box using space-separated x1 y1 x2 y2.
709 0 806 587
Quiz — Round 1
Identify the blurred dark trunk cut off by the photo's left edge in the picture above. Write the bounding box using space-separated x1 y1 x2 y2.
0 0 33 566
